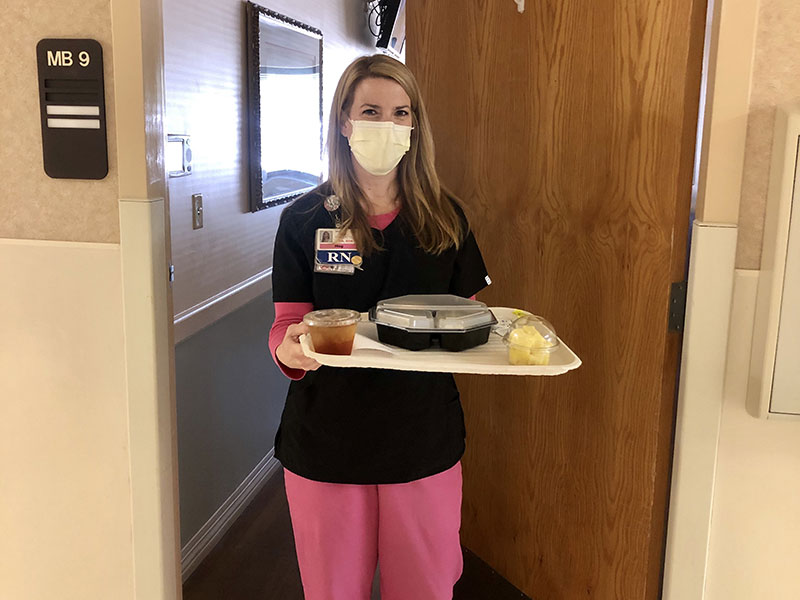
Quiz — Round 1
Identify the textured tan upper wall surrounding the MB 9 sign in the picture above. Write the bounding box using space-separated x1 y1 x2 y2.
0 0 119 242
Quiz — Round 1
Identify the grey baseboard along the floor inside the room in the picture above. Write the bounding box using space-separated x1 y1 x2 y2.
181 448 280 582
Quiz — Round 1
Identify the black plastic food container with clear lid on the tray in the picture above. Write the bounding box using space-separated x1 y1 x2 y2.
369 294 497 352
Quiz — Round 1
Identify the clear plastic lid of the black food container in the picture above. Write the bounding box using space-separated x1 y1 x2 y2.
370 294 497 333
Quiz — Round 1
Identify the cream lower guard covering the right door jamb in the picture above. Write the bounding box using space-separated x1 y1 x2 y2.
662 221 737 600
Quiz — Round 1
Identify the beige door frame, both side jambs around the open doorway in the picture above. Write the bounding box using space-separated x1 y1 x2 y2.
122 0 758 600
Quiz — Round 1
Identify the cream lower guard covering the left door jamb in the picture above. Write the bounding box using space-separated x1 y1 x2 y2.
119 198 178 600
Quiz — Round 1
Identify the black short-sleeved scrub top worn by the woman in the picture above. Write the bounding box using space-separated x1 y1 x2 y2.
272 184 488 484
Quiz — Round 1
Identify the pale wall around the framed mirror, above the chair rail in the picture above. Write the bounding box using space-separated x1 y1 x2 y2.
164 0 372 314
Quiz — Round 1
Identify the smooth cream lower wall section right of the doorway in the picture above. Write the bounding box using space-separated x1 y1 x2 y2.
706 270 800 600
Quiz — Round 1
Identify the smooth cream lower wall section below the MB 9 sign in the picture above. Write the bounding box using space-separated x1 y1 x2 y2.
0 239 134 600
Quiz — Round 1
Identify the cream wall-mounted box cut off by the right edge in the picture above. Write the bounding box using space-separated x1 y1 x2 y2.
747 103 800 419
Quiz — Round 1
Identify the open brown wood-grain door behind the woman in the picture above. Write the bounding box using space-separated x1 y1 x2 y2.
407 0 706 600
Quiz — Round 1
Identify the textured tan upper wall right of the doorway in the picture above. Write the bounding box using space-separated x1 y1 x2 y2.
736 0 800 269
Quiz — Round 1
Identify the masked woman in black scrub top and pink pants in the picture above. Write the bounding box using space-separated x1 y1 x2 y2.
270 55 489 600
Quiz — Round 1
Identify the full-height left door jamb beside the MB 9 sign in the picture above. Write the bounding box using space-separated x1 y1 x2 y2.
109 0 182 600
